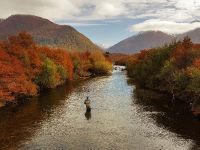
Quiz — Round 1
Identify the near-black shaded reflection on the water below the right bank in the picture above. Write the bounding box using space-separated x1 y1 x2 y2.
134 88 200 147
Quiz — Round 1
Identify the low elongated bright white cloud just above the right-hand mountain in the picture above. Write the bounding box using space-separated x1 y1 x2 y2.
129 19 200 34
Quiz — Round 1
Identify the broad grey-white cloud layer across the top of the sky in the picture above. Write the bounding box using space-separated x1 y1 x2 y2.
0 0 200 22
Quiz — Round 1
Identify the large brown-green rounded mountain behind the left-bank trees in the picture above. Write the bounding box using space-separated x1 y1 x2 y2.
0 15 100 51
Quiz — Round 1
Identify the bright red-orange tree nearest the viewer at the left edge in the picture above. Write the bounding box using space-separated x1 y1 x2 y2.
0 49 37 101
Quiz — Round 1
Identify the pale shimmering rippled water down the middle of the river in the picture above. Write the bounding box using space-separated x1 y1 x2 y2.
0 69 197 150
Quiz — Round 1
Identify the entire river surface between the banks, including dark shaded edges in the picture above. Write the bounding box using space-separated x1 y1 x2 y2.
0 68 200 150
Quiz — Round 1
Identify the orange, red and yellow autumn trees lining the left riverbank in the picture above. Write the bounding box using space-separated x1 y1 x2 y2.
0 32 112 103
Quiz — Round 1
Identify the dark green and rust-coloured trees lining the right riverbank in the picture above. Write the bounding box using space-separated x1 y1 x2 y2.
126 37 200 104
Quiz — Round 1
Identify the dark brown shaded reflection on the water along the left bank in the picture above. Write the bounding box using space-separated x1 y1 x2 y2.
0 85 76 149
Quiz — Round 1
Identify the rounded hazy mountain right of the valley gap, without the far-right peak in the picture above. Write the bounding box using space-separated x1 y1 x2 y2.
108 31 174 54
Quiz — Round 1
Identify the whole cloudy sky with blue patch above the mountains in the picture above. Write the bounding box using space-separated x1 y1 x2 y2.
0 0 200 48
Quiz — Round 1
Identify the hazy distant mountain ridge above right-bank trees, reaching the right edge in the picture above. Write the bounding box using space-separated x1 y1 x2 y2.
108 28 200 54
